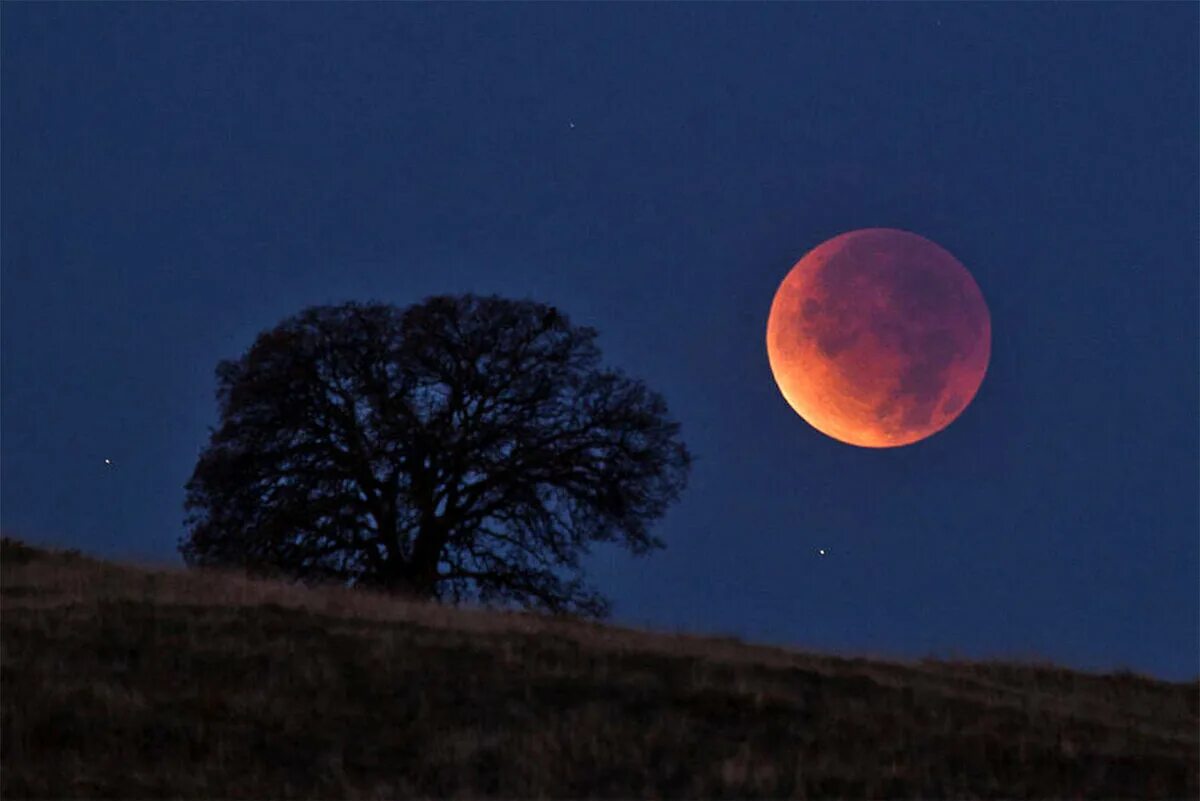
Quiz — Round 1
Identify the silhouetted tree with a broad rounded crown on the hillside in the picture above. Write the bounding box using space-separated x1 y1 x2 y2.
180 295 691 616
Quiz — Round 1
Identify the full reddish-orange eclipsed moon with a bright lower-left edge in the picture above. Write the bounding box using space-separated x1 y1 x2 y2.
767 228 991 447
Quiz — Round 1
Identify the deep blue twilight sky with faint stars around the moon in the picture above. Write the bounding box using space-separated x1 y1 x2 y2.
0 4 1200 677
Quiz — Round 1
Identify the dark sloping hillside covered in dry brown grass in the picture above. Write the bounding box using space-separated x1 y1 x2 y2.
0 540 1200 799
